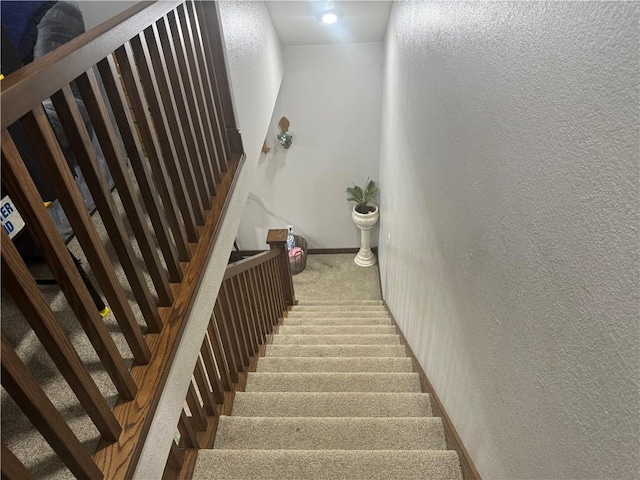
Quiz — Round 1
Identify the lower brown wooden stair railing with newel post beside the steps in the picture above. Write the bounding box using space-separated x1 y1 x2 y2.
163 230 296 479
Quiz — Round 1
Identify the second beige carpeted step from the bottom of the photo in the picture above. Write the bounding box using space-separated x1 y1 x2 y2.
214 416 447 450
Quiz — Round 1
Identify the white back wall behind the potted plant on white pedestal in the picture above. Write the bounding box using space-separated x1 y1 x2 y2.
239 43 383 250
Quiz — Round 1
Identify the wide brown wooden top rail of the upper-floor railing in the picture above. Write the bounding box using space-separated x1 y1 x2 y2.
0 0 182 129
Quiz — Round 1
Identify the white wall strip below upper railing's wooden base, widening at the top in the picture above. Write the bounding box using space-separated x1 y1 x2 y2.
135 2 282 479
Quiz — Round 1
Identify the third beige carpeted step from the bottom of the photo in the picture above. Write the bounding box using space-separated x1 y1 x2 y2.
232 392 432 417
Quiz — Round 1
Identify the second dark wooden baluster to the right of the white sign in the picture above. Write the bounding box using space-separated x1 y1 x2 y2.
23 107 151 364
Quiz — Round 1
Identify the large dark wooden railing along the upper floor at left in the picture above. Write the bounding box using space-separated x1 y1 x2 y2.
0 0 246 479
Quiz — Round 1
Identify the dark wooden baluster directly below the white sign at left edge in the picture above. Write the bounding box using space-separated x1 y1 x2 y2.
2 234 122 441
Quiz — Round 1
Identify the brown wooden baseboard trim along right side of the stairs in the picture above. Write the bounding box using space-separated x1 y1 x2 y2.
383 306 482 480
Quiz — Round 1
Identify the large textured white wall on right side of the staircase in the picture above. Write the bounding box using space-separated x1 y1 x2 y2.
380 2 640 479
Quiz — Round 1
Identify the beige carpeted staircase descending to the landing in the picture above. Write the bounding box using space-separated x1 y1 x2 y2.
193 300 462 480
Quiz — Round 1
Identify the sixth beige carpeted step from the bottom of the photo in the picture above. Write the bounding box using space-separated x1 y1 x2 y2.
265 344 407 357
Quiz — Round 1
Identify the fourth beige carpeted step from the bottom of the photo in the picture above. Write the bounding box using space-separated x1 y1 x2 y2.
245 372 422 393
